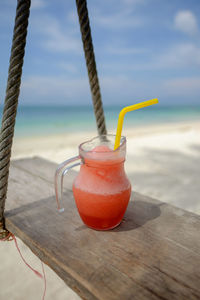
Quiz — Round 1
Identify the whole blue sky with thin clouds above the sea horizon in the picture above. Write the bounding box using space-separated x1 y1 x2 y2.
0 0 200 106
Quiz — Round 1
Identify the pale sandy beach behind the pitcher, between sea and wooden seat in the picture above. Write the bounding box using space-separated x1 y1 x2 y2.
12 118 200 213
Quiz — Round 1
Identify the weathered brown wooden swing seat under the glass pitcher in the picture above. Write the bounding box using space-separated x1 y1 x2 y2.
3 158 200 300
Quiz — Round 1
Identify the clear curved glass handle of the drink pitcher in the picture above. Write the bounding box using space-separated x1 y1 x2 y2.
55 156 83 212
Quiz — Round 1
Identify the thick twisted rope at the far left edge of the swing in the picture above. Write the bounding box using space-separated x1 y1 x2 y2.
0 0 30 238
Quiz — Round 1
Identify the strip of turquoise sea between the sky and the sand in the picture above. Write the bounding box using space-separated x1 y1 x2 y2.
0 105 200 137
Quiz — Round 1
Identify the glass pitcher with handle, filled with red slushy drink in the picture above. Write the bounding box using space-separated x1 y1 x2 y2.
55 135 131 230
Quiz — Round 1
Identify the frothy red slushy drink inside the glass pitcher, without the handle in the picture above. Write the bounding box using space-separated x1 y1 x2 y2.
73 146 131 230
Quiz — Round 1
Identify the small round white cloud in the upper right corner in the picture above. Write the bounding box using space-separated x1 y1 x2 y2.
174 10 198 35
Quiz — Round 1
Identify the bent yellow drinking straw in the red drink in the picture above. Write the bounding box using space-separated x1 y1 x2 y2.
114 98 158 150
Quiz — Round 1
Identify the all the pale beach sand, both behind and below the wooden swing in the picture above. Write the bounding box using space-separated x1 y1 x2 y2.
0 122 200 300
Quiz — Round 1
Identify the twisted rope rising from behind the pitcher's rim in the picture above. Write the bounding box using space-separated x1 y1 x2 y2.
76 0 106 135
